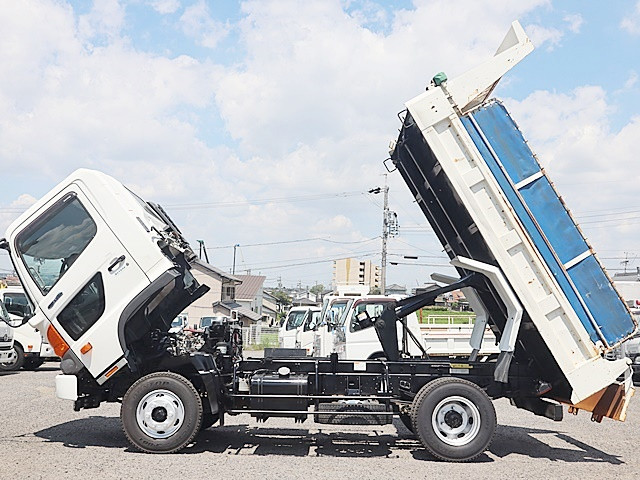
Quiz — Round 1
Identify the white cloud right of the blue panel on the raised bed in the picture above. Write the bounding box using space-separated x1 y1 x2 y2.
506 86 640 258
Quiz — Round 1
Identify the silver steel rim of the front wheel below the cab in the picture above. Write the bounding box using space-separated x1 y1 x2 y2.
136 390 185 439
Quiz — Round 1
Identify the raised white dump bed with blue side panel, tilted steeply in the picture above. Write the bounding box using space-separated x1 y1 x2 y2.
391 22 637 419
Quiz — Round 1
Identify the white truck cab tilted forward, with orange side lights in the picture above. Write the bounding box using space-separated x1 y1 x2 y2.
0 169 208 386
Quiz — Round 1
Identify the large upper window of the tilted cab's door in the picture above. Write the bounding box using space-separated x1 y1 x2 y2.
16 194 97 295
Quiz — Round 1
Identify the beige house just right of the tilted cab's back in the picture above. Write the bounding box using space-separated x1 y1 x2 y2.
182 260 240 325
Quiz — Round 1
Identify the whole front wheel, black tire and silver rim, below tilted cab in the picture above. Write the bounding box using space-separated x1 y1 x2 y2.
120 372 202 453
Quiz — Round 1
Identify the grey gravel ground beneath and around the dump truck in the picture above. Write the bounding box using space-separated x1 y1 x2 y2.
0 364 640 480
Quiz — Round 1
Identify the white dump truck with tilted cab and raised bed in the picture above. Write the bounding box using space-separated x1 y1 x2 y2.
0 22 637 461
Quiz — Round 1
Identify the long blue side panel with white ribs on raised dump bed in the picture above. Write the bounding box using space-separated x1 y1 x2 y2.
462 102 635 345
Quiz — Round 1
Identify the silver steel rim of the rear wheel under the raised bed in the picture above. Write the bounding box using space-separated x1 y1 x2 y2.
431 396 481 447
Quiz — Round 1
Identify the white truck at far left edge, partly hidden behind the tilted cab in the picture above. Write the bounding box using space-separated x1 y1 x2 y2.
0 287 57 371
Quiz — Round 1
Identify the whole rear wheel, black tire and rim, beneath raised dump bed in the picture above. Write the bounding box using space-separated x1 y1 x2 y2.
411 377 496 462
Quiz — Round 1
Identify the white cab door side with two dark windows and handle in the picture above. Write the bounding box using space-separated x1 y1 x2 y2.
13 184 150 383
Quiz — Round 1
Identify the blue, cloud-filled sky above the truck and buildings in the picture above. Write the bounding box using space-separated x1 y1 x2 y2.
0 0 640 289
